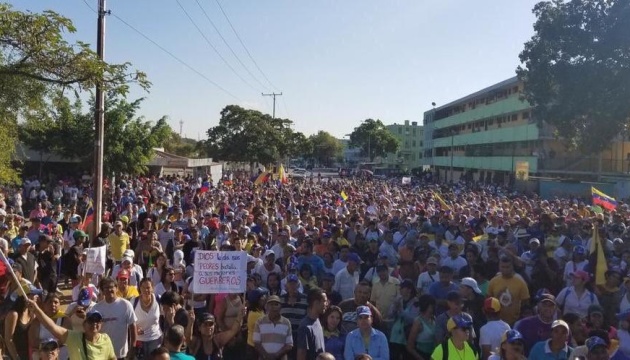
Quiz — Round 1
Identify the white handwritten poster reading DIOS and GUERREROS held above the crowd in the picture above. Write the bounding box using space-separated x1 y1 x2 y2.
193 250 247 294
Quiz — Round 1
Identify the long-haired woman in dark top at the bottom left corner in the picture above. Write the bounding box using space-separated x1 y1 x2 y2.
4 296 33 359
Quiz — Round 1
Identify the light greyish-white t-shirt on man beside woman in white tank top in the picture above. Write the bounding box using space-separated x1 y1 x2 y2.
93 298 138 358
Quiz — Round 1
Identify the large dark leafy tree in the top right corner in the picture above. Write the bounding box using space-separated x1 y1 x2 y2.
517 0 630 153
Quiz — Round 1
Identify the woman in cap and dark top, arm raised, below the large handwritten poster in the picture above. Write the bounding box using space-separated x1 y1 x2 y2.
186 311 243 360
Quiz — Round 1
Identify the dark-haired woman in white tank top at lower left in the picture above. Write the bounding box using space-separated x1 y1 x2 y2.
131 277 162 359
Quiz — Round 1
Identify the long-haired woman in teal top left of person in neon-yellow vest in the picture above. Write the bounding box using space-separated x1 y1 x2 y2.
407 294 436 359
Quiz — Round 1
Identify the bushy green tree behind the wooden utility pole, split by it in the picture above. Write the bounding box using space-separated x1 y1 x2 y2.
20 93 172 174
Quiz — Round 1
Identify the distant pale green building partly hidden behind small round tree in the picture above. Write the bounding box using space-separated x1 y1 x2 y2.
383 120 424 171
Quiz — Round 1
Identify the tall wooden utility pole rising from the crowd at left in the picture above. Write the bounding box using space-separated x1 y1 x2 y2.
92 0 110 239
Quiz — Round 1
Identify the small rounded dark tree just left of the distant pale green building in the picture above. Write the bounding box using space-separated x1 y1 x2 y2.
348 119 400 161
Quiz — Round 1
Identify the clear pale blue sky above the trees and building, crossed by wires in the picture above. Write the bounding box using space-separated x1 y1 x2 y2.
9 0 537 139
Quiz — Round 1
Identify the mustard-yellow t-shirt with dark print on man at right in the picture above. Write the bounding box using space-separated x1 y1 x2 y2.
488 274 529 326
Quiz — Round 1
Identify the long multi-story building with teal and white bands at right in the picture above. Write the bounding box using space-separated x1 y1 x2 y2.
423 77 630 183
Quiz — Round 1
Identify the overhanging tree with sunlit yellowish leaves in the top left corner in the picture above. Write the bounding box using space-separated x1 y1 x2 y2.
0 3 149 182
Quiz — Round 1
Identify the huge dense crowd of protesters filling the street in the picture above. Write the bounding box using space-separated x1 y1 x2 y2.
0 173 630 360
